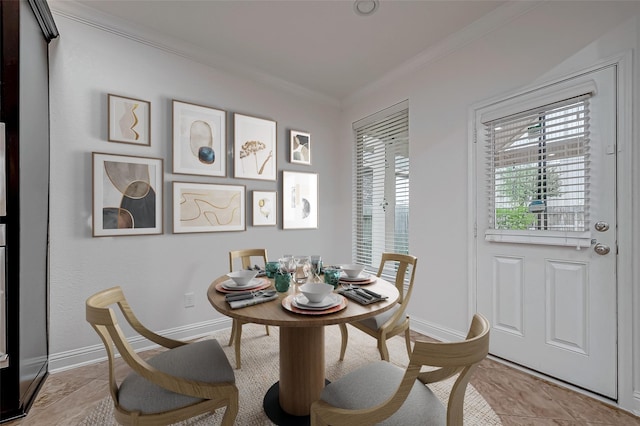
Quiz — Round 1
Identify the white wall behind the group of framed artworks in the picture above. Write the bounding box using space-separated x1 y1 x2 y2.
50 11 351 370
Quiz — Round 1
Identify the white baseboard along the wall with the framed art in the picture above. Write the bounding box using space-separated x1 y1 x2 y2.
49 318 231 373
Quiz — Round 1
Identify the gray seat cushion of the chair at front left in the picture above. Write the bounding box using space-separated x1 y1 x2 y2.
118 339 235 414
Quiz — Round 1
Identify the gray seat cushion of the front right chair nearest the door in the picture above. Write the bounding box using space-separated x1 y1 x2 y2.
320 361 447 426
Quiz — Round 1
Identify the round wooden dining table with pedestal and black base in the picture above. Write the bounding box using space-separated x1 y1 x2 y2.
207 275 400 425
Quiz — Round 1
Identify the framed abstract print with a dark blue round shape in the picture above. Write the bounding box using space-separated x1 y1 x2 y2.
173 100 227 176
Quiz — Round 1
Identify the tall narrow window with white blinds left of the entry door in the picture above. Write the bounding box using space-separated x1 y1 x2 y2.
353 101 409 274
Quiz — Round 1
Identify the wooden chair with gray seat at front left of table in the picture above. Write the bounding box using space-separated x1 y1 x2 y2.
86 287 238 425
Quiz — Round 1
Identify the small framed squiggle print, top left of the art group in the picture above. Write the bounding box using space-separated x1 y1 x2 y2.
107 94 151 146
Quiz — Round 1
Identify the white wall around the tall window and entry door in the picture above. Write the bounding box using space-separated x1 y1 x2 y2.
340 2 640 412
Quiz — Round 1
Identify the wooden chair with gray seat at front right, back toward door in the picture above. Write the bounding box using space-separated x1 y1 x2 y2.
311 314 490 426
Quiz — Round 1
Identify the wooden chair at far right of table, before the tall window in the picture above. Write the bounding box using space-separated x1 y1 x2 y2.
340 253 418 361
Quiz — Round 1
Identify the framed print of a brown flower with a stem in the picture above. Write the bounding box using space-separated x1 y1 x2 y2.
233 114 277 181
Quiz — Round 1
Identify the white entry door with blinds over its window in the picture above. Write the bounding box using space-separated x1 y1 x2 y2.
475 66 617 399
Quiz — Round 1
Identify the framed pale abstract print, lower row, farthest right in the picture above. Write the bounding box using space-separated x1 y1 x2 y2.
282 171 318 229
